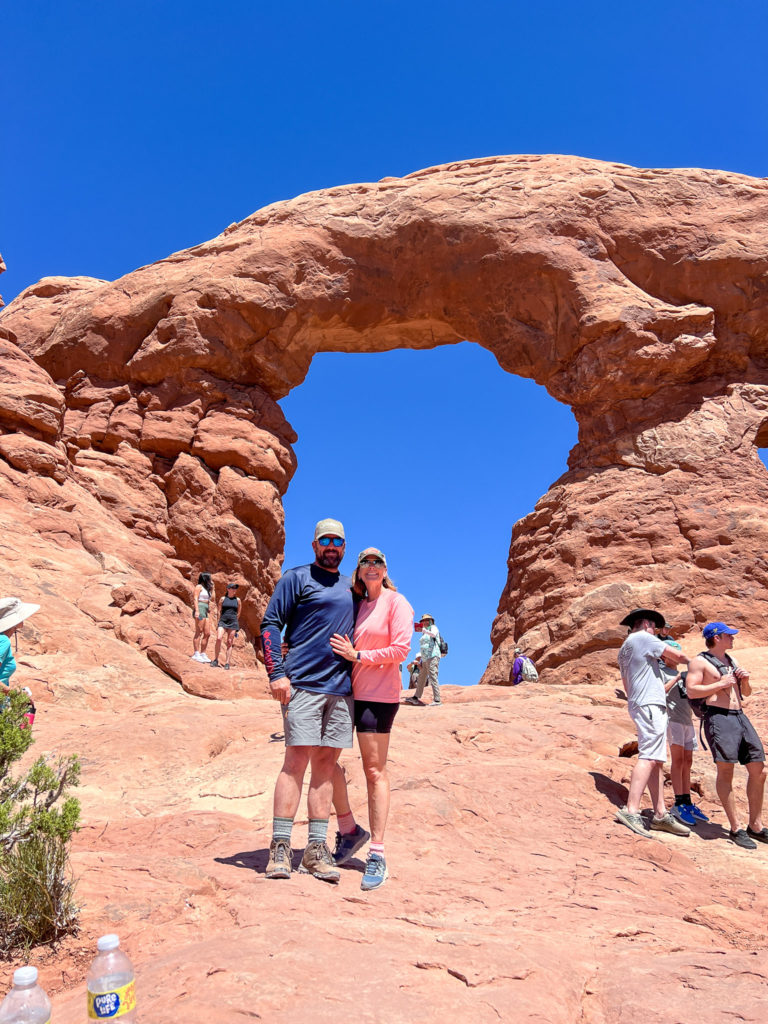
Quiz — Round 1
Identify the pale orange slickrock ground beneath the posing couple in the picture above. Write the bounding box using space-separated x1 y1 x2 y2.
6 651 768 1024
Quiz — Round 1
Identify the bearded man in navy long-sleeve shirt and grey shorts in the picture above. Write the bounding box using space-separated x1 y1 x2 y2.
261 519 354 882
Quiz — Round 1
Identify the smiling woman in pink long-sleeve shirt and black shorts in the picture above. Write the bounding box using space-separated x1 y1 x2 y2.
331 548 414 891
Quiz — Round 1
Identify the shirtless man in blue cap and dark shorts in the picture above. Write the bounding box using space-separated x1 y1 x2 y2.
685 623 768 850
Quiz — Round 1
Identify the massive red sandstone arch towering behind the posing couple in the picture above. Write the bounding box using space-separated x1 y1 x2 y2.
0 157 768 682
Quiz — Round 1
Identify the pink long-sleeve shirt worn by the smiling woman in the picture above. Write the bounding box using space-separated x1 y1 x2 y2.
352 588 414 703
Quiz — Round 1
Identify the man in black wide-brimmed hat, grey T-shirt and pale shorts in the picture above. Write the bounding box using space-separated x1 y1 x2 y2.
615 608 690 836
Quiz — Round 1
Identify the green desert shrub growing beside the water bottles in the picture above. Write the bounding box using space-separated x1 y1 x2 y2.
0 691 80 956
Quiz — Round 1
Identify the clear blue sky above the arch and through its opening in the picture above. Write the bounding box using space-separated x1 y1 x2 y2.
0 0 768 683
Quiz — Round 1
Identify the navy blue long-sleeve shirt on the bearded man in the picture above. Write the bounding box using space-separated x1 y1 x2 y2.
261 564 354 694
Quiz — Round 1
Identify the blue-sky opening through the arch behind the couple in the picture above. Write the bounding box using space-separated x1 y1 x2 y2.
281 342 577 685
